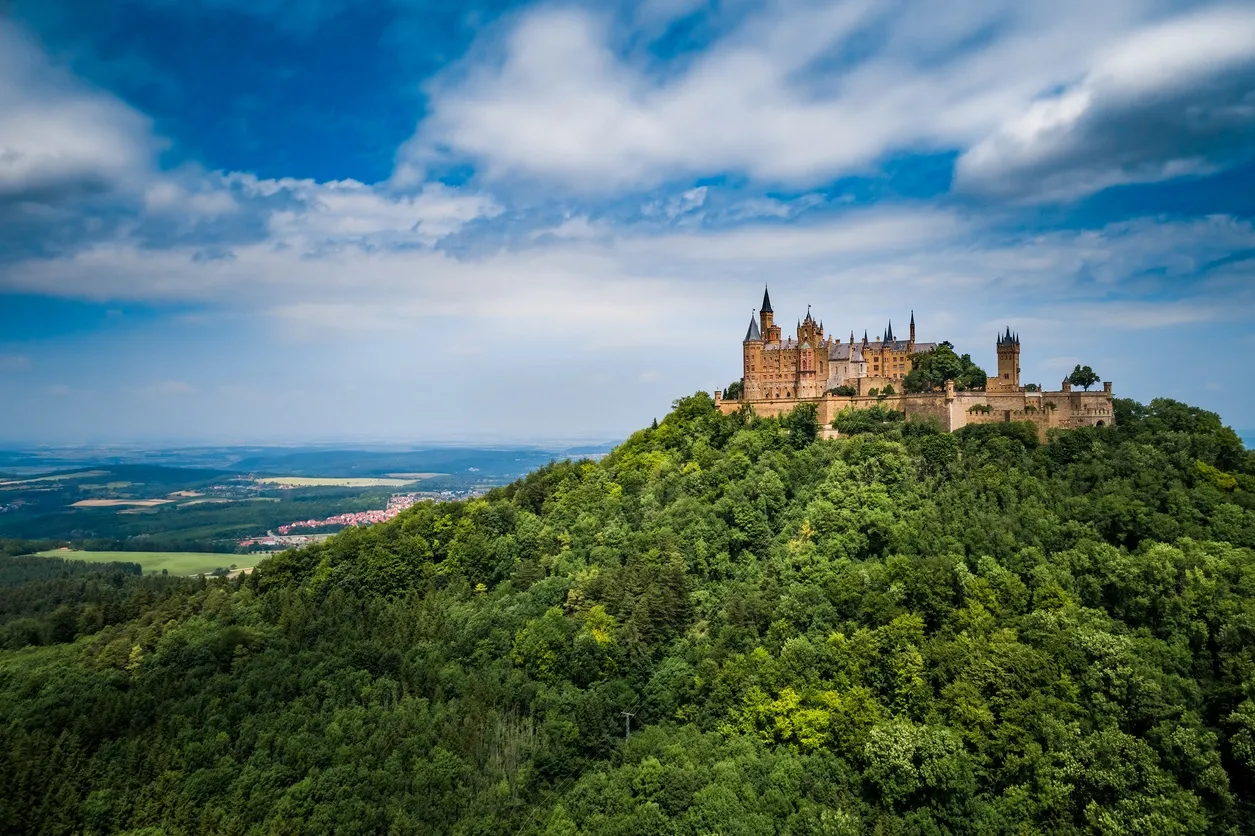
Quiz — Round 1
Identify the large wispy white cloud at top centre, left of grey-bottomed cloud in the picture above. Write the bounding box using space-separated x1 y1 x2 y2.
399 0 1204 192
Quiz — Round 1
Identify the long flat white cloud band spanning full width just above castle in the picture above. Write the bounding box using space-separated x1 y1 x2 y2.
0 207 1255 346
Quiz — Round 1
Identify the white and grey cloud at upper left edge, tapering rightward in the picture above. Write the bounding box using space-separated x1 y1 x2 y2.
0 20 502 261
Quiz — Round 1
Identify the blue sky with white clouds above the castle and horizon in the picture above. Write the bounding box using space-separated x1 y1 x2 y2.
0 0 1255 444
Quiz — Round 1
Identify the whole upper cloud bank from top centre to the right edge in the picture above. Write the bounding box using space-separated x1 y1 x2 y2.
402 0 1255 198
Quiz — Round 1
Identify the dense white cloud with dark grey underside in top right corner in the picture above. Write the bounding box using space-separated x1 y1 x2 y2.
955 8 1255 200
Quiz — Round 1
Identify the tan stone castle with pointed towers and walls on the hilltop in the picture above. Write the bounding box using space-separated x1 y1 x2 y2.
715 289 1114 438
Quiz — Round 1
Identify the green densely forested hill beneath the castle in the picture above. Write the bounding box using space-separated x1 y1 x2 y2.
0 395 1255 836
